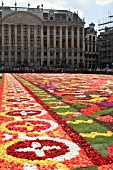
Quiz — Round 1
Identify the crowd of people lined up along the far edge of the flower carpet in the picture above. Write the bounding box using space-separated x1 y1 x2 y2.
0 67 113 74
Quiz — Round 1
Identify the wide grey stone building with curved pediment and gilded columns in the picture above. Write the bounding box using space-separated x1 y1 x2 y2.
0 4 85 68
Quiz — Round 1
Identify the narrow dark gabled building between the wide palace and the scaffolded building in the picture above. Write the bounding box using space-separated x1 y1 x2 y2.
84 23 99 69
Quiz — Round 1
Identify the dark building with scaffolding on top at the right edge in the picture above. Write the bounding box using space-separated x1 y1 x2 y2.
98 15 113 69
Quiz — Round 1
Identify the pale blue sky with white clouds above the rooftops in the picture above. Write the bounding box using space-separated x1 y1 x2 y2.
1 0 113 31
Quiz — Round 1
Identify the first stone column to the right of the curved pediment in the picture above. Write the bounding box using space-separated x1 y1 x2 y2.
47 26 50 66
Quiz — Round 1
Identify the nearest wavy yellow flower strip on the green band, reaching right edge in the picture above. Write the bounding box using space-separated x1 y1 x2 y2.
80 131 113 138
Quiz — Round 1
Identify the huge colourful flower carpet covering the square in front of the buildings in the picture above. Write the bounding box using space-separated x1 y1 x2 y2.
0 73 113 170
